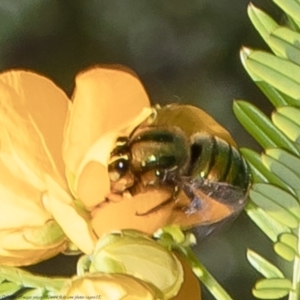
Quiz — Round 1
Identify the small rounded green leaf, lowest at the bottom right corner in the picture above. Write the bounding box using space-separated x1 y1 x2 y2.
252 278 292 299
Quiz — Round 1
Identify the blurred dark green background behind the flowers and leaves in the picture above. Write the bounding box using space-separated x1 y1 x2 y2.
0 0 285 300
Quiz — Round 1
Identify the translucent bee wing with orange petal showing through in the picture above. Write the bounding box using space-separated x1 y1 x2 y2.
169 178 247 237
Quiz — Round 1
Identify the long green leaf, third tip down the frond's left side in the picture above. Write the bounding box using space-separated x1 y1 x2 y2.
233 101 299 154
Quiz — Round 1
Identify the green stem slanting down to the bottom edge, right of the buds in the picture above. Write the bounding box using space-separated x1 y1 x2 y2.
176 246 233 300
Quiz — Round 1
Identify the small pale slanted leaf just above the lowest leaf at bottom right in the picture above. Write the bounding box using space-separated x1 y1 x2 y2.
247 249 284 278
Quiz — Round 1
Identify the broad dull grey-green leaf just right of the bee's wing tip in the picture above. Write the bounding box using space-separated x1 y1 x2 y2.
250 189 298 228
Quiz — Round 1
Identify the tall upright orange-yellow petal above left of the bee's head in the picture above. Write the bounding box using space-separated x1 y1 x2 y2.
64 66 149 178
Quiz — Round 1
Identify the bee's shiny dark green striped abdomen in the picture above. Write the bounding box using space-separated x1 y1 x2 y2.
189 133 249 188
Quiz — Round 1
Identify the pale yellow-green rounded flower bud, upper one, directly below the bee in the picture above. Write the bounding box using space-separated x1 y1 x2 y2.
84 230 183 299
